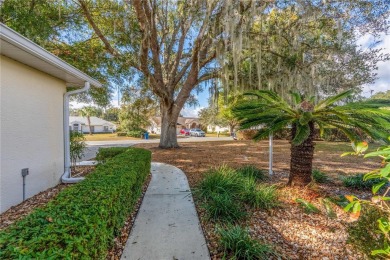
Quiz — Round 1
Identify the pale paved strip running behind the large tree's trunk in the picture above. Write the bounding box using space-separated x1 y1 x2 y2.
81 137 232 161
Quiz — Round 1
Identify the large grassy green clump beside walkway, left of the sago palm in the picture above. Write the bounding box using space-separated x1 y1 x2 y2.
195 166 279 222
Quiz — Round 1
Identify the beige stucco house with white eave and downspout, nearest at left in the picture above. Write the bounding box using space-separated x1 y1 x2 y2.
0 23 100 213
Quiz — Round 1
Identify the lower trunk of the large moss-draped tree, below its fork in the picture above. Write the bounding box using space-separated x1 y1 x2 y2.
159 101 180 149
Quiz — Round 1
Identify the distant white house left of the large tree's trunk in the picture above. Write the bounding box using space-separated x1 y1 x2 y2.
69 116 116 134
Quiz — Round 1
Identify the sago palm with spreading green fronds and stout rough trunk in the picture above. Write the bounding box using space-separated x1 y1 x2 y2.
233 90 390 186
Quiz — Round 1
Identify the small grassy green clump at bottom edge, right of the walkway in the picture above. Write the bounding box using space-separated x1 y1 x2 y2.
218 226 273 260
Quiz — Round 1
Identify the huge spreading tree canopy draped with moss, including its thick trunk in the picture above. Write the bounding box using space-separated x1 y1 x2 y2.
0 0 390 148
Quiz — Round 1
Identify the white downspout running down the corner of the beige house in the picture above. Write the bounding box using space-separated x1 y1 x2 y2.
61 82 90 183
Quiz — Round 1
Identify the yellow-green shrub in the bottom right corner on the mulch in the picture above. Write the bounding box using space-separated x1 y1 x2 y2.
347 205 386 259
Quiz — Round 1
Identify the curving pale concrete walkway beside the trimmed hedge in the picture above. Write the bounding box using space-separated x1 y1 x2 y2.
121 163 210 260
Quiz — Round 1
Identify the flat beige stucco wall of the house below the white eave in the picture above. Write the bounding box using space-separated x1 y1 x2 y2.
0 55 66 213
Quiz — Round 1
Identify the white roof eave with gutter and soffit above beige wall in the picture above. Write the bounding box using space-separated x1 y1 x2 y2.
0 23 102 87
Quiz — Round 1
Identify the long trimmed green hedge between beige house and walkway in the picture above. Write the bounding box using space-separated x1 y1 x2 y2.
0 148 151 259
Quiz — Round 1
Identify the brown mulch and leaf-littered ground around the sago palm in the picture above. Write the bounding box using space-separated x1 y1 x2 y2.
137 140 379 260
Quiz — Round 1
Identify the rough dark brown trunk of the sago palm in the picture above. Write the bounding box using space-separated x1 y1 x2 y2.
287 122 315 186
